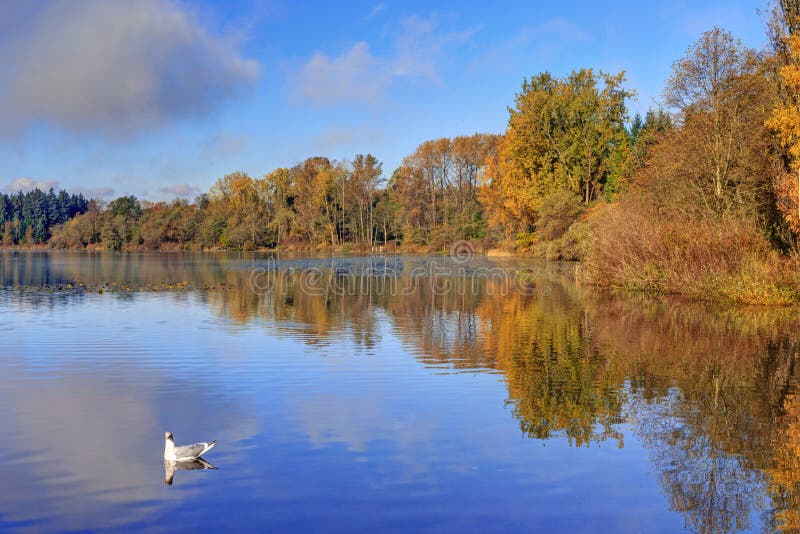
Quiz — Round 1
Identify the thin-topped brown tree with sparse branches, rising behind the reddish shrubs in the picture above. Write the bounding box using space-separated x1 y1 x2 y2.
665 28 775 222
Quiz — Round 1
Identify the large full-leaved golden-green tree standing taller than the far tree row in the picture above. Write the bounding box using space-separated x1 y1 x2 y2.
488 69 633 239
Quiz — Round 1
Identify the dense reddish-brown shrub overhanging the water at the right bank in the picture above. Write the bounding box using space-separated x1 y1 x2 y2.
584 195 800 305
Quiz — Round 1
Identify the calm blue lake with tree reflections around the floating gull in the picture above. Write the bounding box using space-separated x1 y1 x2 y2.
0 251 800 532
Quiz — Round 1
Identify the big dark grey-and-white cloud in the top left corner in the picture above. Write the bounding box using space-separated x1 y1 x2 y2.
0 0 259 134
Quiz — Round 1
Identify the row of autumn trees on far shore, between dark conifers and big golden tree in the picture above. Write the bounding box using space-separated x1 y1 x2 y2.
45 134 499 250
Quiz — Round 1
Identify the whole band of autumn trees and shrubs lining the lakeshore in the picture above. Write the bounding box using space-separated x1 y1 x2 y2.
0 0 800 304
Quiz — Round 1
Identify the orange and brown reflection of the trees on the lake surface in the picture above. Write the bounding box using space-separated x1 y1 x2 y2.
0 254 800 532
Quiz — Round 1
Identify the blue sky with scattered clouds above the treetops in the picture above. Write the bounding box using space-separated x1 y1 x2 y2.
0 0 766 200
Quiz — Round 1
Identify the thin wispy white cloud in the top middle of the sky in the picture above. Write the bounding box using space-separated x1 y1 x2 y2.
289 17 475 106
